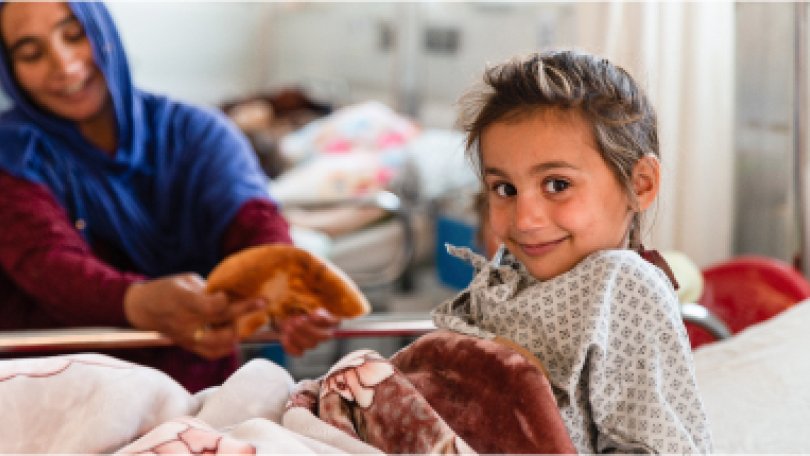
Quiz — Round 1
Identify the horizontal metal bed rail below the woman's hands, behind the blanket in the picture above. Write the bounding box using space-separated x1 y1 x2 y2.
0 313 436 353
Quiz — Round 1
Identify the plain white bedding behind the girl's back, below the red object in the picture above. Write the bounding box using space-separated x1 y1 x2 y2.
695 301 810 453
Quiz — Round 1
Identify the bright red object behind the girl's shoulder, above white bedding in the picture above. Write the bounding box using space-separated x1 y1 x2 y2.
686 255 810 349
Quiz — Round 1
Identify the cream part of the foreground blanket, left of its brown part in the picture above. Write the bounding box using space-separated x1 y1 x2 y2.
0 354 379 454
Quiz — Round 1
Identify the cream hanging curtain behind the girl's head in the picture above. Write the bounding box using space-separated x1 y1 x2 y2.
576 2 735 266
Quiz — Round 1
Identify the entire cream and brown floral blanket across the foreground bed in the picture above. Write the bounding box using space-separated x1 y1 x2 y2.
0 330 575 454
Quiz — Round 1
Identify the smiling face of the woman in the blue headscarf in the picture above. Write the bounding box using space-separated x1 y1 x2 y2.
0 2 109 123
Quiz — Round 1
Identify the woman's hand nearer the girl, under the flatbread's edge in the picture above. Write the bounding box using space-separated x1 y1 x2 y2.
276 309 339 356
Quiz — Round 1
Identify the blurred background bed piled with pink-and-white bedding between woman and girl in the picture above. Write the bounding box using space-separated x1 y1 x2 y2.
222 97 478 302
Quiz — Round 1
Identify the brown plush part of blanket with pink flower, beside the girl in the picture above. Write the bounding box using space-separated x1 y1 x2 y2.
289 330 576 454
